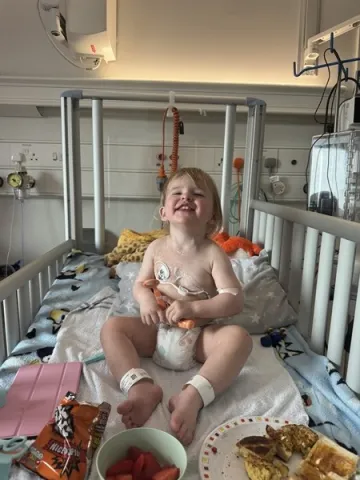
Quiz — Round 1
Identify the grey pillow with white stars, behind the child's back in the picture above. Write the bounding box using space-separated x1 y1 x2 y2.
110 250 296 335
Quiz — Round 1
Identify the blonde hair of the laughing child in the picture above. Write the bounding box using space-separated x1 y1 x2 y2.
161 167 223 237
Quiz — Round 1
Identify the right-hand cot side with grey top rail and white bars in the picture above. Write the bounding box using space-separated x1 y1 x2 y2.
250 200 360 394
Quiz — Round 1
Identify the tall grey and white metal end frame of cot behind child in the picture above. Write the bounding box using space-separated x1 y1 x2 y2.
61 90 266 253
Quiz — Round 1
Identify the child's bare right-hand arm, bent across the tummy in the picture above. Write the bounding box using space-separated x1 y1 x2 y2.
191 246 244 319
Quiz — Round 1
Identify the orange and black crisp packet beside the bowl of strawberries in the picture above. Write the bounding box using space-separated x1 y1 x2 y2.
18 392 111 480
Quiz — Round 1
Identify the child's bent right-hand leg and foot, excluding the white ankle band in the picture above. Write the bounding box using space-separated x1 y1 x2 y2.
169 325 252 445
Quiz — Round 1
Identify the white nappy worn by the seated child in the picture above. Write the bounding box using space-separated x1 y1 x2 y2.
153 324 201 370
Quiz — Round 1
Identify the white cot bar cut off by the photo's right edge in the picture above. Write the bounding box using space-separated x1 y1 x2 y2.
346 279 360 394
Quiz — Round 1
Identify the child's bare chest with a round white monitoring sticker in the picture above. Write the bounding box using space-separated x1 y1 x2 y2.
154 237 217 301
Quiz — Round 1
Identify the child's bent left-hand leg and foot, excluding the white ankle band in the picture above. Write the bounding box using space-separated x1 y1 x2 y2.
101 317 162 428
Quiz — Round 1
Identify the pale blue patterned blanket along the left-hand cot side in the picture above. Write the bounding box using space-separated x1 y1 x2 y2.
0 250 118 390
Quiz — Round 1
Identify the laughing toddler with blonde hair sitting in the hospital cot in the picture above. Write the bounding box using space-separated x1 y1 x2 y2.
101 168 252 445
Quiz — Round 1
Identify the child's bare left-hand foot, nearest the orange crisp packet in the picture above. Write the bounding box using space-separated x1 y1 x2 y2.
117 380 163 428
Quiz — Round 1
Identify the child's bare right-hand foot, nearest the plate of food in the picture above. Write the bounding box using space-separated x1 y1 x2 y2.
169 385 203 445
